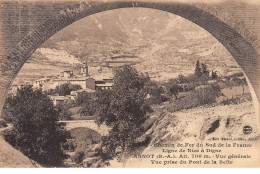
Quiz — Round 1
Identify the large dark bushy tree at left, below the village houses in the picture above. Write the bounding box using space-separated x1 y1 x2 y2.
2 86 68 165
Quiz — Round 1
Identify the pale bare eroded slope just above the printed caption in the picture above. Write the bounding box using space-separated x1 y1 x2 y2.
146 101 257 150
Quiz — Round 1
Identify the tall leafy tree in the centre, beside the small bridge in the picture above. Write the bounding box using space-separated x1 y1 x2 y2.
96 65 147 163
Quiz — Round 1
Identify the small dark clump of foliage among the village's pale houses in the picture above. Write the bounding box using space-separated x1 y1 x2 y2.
46 83 82 96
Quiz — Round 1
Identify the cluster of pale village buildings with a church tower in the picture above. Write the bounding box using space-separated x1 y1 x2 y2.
8 62 114 106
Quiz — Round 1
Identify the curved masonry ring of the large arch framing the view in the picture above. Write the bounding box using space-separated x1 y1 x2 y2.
0 1 260 126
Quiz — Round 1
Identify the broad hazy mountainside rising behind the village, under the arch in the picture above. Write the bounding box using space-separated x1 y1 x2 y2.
19 8 241 81
